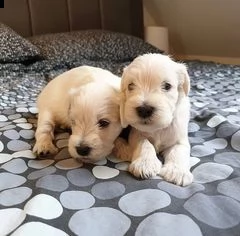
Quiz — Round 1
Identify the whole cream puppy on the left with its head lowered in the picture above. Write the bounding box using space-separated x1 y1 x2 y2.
33 66 122 162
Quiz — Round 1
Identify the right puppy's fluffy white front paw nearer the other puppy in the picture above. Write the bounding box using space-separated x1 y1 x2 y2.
129 157 162 179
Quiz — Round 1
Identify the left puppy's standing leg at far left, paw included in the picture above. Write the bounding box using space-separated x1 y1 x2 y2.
33 111 58 155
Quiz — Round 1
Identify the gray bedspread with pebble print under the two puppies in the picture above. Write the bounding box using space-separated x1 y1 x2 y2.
0 32 240 236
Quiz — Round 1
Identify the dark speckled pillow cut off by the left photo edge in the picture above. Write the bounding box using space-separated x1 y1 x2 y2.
0 22 40 63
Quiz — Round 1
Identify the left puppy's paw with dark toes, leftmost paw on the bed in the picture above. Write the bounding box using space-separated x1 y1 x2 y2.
33 141 58 156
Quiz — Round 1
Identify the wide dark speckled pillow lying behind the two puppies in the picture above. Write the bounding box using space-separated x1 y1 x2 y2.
29 30 162 62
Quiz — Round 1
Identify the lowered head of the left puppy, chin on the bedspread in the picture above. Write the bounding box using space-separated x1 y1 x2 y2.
69 78 122 162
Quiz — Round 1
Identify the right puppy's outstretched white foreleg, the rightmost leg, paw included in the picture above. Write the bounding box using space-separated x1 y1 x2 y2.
160 143 193 186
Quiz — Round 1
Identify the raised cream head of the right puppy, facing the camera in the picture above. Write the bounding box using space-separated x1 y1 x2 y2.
120 54 190 132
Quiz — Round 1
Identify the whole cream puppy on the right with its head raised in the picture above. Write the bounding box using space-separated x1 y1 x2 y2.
114 54 193 186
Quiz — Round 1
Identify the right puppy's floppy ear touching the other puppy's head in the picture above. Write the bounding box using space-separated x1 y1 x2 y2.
120 68 128 128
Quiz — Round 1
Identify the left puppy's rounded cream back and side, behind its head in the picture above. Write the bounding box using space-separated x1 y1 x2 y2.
37 66 120 123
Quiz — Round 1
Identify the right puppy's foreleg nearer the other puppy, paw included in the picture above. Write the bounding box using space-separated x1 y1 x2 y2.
129 129 162 179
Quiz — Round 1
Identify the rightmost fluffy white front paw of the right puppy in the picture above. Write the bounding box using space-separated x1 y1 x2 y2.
160 163 193 186
